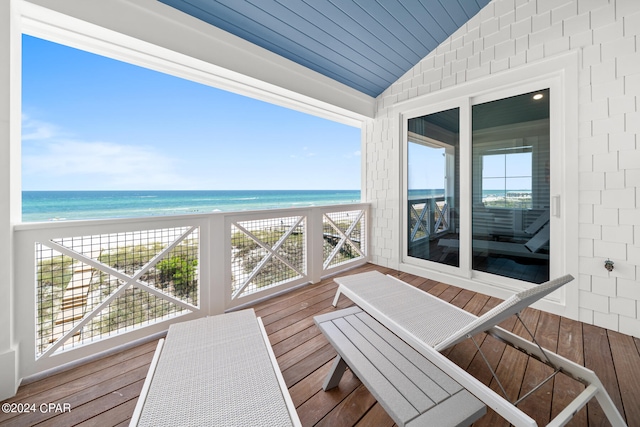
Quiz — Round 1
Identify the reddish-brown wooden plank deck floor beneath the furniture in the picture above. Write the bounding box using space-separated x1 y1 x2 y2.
0 265 640 427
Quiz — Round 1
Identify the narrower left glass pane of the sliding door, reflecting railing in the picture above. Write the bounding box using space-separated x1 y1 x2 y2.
407 108 460 267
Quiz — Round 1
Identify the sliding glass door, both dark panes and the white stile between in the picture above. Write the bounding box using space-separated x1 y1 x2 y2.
405 89 551 283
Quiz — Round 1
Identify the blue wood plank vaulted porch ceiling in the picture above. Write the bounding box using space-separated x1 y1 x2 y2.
159 0 490 97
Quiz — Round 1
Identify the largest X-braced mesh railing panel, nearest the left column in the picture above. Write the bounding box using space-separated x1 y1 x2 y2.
36 226 199 357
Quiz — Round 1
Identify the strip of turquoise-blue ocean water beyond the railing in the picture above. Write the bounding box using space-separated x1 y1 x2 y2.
22 190 360 222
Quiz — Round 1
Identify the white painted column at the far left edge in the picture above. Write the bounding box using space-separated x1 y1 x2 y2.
0 0 22 400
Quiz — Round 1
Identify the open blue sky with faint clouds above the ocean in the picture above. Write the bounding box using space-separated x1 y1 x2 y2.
22 36 360 190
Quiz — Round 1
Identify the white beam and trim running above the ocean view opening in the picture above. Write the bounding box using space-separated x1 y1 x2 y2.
20 0 375 127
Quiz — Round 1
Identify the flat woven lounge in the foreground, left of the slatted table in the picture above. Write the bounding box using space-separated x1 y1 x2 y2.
130 309 300 427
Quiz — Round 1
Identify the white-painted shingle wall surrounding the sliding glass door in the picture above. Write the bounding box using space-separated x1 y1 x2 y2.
365 0 640 337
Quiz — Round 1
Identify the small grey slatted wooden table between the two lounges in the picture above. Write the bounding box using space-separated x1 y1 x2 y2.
314 307 486 427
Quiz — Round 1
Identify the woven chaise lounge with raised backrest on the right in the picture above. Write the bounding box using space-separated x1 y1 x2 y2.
333 271 626 427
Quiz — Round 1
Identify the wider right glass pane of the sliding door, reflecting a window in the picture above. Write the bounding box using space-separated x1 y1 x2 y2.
471 90 551 283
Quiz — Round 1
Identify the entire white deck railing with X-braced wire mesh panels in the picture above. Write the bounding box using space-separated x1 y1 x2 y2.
14 204 369 376
